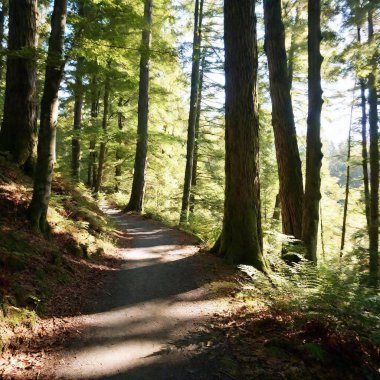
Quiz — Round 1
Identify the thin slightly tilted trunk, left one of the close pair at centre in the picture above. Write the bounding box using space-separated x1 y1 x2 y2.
180 0 203 224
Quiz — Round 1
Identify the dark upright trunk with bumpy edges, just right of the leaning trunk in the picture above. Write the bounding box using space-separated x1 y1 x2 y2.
302 0 323 263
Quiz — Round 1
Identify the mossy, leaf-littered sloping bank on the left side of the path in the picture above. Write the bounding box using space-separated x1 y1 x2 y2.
0 161 115 348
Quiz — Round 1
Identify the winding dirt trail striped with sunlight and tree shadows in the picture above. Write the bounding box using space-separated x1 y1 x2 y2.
53 206 232 380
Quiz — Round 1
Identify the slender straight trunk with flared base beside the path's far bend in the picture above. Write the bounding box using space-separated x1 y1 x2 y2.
125 0 153 212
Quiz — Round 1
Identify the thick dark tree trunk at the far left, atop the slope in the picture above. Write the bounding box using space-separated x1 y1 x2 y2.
0 0 37 169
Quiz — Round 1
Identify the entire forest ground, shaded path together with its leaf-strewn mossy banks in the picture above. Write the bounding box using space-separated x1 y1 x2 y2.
0 162 380 380
